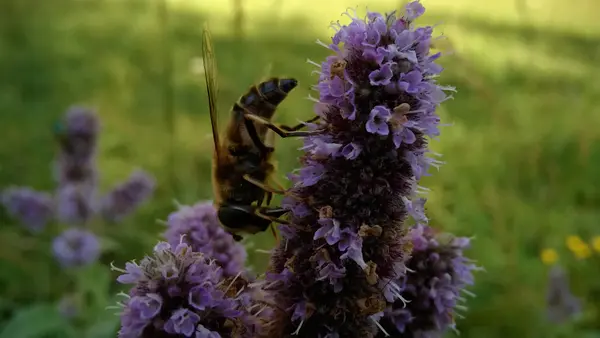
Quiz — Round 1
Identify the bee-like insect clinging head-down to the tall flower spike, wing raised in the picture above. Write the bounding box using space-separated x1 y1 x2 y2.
202 27 318 241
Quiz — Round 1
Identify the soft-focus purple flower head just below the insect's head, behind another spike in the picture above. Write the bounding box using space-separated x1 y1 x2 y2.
164 202 246 277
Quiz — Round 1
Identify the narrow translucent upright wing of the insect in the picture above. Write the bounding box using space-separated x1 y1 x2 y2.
202 25 221 158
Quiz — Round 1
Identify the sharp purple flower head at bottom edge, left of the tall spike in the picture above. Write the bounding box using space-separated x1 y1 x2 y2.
113 242 261 338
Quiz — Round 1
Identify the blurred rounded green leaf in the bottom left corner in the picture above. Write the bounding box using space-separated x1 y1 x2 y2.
0 304 69 338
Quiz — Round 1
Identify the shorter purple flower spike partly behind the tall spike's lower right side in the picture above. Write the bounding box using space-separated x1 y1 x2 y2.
379 224 480 338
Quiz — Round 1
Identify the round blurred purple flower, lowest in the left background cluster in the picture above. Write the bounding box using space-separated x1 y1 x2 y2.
52 228 100 268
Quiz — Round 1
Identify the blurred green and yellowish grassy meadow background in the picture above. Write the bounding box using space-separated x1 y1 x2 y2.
0 0 600 338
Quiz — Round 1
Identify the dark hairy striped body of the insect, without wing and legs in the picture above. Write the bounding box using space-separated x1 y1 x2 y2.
212 78 297 238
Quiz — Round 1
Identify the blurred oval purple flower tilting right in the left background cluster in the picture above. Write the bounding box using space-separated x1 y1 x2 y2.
100 170 156 222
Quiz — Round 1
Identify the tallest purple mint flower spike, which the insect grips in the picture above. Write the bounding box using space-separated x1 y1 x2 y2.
263 2 453 338
